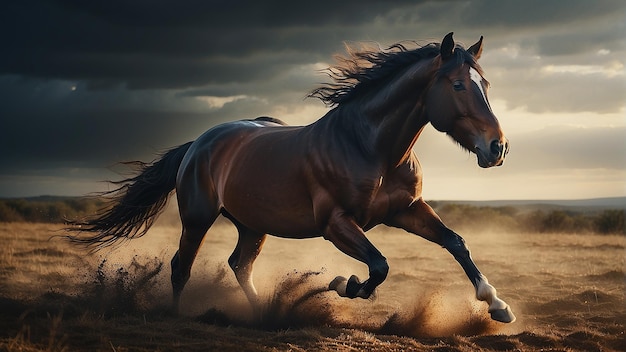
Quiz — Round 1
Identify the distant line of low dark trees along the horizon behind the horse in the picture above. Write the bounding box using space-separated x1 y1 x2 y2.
0 197 626 235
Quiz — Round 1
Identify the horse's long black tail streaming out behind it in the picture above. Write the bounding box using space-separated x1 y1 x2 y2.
67 142 192 249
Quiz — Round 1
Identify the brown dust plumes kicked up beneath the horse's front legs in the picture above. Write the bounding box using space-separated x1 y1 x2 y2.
198 271 502 338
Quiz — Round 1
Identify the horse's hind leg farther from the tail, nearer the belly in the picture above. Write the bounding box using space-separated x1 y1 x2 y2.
225 214 267 318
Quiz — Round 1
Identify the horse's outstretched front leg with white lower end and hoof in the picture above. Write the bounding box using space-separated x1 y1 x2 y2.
385 199 515 323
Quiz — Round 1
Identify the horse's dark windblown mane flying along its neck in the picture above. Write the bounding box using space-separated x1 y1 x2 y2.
308 42 482 106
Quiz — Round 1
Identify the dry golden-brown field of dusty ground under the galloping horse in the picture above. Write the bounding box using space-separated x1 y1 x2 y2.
0 208 626 351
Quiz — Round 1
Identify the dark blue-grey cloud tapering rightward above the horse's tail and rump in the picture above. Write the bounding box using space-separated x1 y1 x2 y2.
0 76 272 174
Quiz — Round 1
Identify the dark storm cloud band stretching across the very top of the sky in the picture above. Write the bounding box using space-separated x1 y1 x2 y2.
0 0 625 89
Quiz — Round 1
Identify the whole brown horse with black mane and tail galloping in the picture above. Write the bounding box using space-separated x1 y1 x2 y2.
68 33 516 323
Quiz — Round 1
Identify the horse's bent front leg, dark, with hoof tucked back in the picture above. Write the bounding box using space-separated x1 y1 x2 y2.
324 211 389 298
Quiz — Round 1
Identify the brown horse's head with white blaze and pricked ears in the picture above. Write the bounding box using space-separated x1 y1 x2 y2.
426 33 509 168
